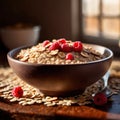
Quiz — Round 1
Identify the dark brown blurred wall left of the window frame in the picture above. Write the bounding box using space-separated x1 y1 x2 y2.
0 0 71 41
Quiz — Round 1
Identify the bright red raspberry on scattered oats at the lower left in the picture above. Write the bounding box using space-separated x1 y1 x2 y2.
12 86 23 98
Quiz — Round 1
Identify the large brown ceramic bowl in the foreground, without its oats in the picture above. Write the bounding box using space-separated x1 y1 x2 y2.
7 44 113 96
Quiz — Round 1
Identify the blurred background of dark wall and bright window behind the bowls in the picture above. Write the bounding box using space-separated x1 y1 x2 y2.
0 0 120 56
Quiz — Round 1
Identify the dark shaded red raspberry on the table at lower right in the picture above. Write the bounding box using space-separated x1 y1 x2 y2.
93 93 107 105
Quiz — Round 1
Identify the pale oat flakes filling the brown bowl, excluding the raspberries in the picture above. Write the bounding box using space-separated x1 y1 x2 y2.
16 39 104 64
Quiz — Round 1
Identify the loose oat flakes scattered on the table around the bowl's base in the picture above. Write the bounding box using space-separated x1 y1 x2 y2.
0 67 120 106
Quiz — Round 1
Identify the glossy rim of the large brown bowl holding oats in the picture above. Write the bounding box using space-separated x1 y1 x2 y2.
7 43 114 66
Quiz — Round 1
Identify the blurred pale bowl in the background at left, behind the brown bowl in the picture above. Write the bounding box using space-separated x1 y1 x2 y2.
1 23 40 50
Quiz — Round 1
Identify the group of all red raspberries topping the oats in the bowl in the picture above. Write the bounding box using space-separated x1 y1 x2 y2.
43 38 83 60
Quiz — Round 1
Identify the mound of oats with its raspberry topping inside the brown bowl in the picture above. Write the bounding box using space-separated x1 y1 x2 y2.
16 39 104 64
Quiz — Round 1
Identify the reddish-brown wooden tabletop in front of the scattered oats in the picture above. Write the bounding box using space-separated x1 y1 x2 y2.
0 48 120 120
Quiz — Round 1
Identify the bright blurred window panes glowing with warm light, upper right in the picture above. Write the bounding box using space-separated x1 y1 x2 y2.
82 0 120 39
